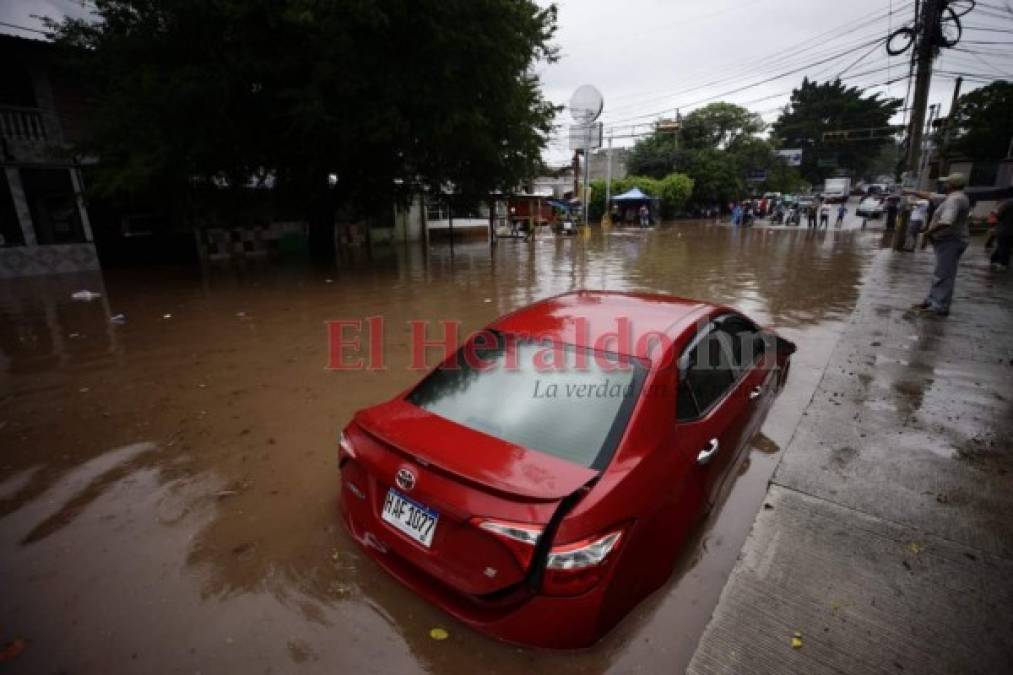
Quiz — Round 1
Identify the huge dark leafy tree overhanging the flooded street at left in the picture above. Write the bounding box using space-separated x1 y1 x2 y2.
51 0 556 255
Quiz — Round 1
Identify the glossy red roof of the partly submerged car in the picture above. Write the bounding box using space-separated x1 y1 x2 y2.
488 291 713 361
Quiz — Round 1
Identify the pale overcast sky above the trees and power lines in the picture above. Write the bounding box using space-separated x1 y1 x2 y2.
0 0 1013 162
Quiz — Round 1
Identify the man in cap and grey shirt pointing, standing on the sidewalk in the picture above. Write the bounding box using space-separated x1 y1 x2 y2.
905 173 970 316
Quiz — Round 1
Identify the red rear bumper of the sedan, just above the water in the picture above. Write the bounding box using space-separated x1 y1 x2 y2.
339 490 611 649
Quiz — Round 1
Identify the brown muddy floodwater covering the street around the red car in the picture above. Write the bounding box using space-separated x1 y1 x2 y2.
0 223 879 673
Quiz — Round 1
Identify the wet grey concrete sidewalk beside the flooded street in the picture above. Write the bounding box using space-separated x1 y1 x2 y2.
689 239 1013 675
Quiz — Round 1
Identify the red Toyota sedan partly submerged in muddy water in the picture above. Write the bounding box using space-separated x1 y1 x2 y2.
338 291 795 649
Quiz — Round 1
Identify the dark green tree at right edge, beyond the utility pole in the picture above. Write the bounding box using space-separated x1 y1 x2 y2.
946 80 1013 160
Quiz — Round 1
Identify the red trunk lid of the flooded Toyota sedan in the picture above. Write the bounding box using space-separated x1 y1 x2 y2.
342 400 598 597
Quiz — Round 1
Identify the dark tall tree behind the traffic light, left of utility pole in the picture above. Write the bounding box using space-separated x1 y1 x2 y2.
772 78 902 184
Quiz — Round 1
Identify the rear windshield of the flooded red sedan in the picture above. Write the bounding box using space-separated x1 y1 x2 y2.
407 333 646 469
